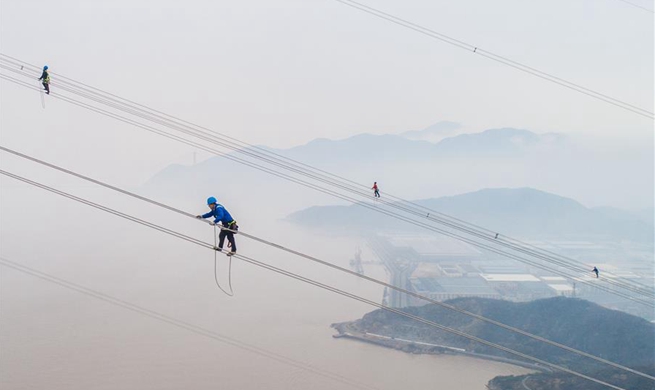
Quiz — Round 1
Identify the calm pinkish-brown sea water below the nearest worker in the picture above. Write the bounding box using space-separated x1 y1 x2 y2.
0 204 528 390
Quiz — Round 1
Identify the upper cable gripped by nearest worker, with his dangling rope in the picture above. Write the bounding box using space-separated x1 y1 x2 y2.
0 155 655 380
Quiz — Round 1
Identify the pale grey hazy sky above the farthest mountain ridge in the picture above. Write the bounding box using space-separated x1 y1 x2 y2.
0 0 653 188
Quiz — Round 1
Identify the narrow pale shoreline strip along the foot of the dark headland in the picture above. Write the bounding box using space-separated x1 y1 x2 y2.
330 322 551 372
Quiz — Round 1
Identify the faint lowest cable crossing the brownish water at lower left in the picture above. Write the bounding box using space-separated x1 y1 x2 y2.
0 257 384 390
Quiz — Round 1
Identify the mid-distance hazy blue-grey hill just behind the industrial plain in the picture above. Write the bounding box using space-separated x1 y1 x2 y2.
288 188 653 242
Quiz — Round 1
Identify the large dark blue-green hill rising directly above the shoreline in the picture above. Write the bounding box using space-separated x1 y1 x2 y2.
338 297 655 371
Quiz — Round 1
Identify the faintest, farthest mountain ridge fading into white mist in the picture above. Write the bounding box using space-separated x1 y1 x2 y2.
143 124 653 221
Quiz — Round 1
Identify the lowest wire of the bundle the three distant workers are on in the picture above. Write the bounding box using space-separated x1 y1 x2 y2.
0 74 653 306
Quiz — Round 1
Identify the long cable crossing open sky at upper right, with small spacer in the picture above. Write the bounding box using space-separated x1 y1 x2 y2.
333 0 655 119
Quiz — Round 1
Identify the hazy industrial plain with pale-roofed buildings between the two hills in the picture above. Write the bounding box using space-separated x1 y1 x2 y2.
370 235 575 308
